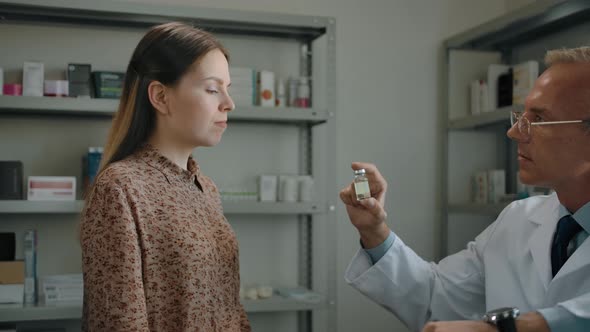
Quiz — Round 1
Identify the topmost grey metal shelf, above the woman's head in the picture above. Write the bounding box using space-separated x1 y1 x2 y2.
0 0 333 40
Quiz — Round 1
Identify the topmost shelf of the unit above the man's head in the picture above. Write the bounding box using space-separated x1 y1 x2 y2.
445 0 590 50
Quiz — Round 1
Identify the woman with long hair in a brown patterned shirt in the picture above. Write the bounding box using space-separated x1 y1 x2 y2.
81 23 250 331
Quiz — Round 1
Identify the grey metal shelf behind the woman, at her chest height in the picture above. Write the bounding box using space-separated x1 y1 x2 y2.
0 200 326 214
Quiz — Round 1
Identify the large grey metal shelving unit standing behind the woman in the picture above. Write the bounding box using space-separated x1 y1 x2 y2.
0 0 338 332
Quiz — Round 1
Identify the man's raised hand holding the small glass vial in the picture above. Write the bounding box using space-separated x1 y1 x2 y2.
340 163 390 248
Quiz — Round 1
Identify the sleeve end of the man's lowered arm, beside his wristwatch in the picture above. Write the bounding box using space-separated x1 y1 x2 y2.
539 293 590 332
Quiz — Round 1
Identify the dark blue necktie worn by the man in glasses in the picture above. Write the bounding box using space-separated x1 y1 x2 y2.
551 215 582 277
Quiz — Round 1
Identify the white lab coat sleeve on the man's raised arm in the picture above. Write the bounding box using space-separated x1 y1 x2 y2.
345 217 501 331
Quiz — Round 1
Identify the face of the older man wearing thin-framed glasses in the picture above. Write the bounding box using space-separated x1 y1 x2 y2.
507 63 590 189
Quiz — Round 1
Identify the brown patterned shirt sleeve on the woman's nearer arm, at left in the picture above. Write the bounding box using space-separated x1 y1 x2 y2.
80 182 149 331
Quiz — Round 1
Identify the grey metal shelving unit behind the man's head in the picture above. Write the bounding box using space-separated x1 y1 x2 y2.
441 0 590 257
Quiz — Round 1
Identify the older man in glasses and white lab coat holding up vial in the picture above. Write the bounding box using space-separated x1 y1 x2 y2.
340 47 590 332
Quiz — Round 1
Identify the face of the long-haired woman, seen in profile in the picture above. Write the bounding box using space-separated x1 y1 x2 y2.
165 49 235 147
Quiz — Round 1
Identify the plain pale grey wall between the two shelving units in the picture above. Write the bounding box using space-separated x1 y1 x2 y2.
112 0 511 332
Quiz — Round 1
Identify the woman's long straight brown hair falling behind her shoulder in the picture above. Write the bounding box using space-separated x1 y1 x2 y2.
99 22 229 174
